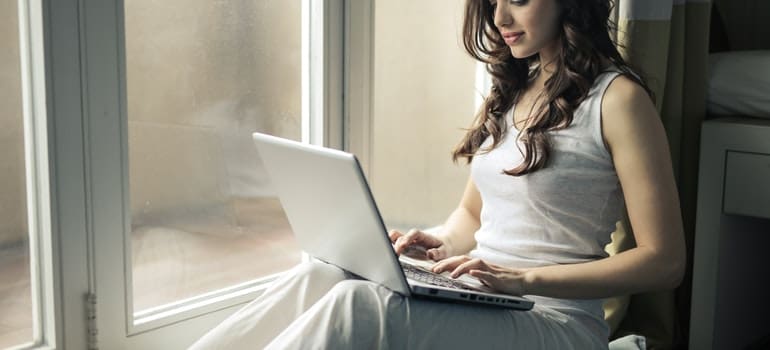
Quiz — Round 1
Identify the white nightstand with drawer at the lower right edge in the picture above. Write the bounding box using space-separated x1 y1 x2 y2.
689 118 770 350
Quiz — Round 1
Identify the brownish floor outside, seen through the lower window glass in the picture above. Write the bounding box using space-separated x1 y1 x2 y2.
0 200 300 349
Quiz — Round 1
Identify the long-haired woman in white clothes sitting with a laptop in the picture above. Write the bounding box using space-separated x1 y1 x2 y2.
193 0 684 349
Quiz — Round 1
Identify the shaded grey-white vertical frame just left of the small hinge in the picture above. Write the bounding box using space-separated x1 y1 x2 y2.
38 0 97 349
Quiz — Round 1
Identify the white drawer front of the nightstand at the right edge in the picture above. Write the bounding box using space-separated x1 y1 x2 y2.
723 151 770 219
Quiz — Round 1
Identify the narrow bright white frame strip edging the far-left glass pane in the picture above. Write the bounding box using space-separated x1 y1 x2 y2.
14 0 58 349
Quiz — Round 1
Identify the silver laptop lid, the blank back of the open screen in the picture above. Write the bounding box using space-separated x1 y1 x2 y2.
253 133 410 295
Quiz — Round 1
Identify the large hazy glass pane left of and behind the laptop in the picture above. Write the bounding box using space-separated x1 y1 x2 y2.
125 0 301 311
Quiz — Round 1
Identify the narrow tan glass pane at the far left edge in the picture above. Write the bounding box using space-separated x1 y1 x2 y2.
0 1 32 348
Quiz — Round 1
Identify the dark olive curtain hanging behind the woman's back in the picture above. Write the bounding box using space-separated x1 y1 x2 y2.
614 0 711 349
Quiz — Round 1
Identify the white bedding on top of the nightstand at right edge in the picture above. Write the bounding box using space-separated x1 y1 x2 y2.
706 50 770 119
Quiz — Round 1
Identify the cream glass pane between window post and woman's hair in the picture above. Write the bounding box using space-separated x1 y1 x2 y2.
369 0 477 228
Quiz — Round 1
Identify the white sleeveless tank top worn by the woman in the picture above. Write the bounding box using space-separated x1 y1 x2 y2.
470 71 623 337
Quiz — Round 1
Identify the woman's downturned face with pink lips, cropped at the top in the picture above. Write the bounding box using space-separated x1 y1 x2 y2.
485 0 560 60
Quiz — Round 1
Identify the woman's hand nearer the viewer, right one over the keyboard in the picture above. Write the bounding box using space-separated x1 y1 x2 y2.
433 255 526 295
